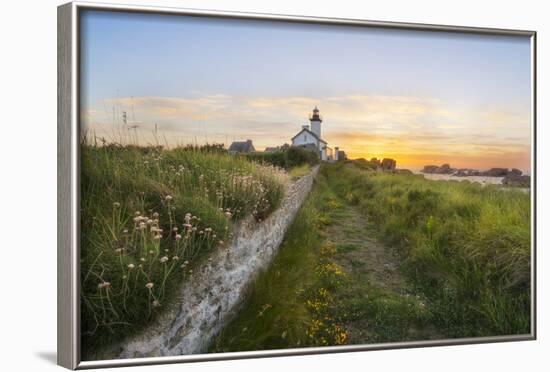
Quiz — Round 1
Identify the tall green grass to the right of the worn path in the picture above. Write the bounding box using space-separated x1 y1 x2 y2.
323 164 530 337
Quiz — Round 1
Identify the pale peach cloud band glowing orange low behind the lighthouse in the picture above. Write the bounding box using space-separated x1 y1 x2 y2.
81 94 530 168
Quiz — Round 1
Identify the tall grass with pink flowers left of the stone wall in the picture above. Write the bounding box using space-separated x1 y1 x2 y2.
81 143 288 358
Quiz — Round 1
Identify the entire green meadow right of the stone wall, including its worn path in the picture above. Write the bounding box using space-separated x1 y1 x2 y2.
210 162 530 352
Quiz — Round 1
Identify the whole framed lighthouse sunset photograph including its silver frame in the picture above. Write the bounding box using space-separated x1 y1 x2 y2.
57 2 536 369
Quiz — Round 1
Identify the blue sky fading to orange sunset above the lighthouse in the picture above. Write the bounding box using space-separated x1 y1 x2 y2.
81 10 532 171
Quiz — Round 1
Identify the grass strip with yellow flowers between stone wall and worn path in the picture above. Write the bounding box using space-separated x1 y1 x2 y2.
209 178 347 352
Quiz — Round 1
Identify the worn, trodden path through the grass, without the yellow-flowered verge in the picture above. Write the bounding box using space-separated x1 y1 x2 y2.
323 195 441 344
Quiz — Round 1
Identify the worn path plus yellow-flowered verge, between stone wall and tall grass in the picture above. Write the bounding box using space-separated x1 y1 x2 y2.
211 169 440 352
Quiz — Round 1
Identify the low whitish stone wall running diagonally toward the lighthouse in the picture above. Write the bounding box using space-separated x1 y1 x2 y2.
113 166 319 358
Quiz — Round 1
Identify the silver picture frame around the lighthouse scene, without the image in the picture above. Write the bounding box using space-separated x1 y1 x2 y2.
57 1 537 369
